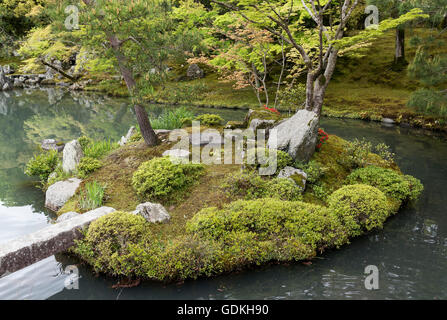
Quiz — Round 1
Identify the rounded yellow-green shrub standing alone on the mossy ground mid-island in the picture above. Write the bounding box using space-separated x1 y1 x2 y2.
132 157 204 199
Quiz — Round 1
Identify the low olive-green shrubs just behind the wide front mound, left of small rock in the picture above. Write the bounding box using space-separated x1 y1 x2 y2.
222 171 302 201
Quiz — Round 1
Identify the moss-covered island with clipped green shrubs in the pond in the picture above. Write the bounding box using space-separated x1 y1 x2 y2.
28 111 423 281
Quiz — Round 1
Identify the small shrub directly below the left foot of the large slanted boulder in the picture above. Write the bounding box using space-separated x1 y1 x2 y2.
244 148 294 173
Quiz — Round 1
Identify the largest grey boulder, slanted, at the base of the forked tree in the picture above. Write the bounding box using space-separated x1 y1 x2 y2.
268 110 319 162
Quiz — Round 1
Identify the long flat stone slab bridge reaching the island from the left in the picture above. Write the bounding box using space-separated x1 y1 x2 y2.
0 207 116 277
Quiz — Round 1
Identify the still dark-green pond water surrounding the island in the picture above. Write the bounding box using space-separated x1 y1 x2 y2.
0 89 447 299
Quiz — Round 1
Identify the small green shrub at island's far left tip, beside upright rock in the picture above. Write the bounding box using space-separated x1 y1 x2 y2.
25 150 59 183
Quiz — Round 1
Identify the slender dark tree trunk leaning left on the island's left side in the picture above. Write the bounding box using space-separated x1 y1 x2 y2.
109 35 158 146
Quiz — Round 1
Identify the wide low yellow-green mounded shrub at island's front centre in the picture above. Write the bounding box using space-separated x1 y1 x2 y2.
187 199 347 261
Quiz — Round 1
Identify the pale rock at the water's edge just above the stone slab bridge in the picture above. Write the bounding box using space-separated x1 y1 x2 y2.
45 178 82 211
